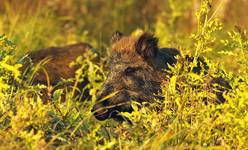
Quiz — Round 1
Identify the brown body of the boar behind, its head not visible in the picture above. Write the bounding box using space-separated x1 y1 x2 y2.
21 43 92 103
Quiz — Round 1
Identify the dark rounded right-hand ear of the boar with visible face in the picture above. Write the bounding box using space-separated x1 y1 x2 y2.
135 33 158 59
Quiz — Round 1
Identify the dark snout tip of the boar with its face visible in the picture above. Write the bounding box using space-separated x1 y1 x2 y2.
91 104 109 121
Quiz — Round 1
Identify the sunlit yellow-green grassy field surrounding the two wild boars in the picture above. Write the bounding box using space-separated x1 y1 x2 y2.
0 0 248 149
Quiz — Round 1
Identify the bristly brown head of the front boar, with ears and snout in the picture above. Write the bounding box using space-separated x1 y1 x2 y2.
92 32 231 120
